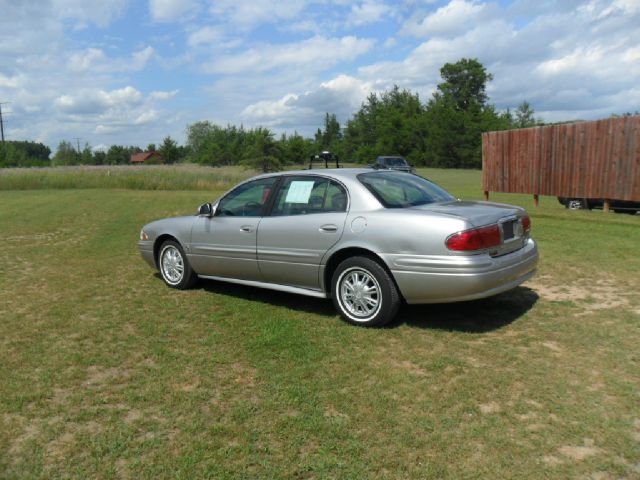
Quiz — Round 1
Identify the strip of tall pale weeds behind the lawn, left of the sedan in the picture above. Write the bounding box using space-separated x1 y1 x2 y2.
0 165 256 191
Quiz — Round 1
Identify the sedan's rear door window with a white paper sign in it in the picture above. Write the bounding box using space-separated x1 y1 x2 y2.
271 176 347 216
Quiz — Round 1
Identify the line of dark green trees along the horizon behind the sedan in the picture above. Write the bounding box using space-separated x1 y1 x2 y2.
0 58 542 171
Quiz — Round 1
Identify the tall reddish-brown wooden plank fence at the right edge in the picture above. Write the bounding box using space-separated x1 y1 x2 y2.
482 116 640 203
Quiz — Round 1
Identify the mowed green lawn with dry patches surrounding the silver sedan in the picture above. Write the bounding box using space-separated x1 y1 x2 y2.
0 170 640 479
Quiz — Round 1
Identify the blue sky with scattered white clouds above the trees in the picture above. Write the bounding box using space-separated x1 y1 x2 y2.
0 0 640 150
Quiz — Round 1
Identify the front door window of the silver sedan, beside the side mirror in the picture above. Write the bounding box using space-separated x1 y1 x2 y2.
216 177 276 217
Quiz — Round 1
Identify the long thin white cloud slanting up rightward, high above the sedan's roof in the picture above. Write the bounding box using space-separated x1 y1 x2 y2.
205 36 375 74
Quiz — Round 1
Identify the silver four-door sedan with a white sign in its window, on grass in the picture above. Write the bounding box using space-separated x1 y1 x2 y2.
138 168 538 326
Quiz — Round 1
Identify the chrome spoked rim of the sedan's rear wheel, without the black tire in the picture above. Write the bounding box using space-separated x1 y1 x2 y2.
338 267 382 322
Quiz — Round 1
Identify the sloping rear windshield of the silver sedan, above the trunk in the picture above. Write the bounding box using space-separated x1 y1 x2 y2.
358 172 455 208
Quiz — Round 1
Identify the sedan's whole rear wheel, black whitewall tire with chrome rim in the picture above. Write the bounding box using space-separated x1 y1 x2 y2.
331 256 401 327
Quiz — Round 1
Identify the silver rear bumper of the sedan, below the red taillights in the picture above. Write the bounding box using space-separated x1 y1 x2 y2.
383 239 538 304
